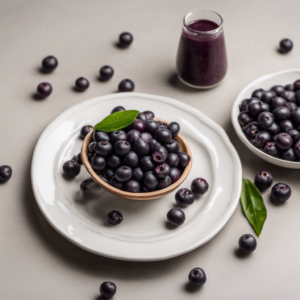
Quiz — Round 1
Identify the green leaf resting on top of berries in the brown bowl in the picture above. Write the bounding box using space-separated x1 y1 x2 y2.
94 110 139 132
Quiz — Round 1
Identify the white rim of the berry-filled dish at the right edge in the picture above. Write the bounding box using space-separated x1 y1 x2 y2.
231 69 300 169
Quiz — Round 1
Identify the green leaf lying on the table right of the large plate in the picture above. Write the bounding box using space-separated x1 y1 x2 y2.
241 179 267 236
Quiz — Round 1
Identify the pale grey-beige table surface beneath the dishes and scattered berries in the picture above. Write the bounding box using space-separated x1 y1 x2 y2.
0 0 300 300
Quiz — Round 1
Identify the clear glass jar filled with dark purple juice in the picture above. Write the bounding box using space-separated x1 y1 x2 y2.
176 10 227 89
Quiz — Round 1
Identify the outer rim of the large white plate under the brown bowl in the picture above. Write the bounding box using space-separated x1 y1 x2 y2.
31 92 242 261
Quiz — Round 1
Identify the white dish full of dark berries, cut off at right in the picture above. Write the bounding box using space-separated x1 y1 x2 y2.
231 69 300 169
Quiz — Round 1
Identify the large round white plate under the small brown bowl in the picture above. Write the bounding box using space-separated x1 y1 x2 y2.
32 93 242 261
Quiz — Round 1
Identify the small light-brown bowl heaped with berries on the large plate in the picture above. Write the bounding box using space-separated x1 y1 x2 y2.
81 118 193 200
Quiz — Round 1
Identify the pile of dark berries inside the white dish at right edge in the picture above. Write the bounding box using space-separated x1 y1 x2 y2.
238 80 300 161
